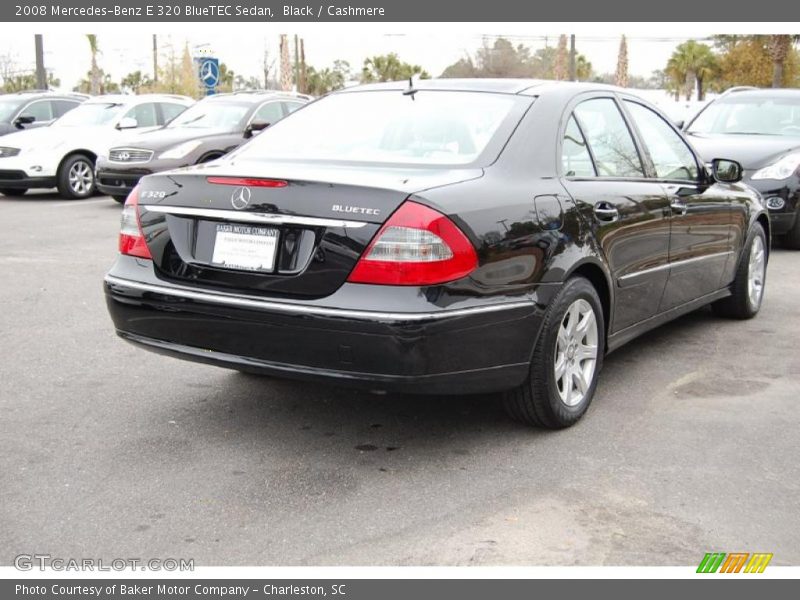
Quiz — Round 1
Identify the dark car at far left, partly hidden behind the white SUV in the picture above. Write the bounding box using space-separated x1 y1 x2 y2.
0 90 89 136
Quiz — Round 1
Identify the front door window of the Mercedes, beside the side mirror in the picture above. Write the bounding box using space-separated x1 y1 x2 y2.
625 100 698 181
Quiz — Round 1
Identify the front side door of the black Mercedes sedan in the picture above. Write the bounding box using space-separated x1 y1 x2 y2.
623 99 733 311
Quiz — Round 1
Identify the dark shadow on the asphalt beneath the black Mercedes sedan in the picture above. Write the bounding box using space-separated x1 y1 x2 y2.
169 309 716 453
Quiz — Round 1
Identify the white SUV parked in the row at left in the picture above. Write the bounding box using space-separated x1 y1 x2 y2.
0 94 194 199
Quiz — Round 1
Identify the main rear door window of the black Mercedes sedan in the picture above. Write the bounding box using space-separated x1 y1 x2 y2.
575 98 644 177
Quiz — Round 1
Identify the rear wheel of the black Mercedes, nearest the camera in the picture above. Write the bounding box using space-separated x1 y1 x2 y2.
504 277 605 429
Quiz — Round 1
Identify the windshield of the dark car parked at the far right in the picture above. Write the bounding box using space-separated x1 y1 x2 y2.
688 95 800 136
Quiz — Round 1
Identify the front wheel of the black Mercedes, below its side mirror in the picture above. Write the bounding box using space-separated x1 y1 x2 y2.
711 223 769 319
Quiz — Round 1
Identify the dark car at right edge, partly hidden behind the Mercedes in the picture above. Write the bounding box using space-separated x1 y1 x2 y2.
685 88 800 250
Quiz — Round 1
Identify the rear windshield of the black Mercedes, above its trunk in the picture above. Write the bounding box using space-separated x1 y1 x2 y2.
231 90 520 165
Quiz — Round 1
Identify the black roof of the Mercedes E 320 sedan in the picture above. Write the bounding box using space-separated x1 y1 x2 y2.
336 79 628 96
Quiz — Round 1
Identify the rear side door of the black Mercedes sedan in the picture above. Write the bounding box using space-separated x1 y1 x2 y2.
562 95 670 333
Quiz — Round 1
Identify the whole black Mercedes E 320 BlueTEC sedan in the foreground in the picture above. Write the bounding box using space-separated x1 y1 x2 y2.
105 80 769 428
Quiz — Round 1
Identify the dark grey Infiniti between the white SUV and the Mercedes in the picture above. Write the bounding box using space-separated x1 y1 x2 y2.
96 91 311 203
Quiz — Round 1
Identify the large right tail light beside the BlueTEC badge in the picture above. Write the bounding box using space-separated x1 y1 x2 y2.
347 201 478 285
